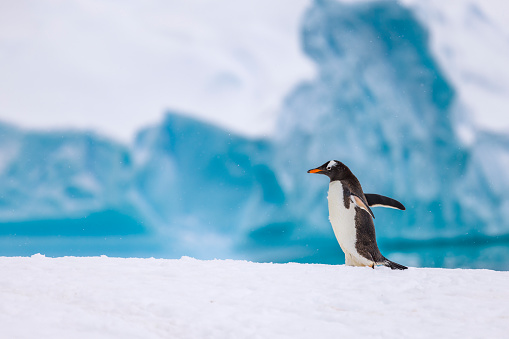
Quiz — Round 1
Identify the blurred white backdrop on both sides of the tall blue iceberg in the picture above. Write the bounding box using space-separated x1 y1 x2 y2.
0 0 509 141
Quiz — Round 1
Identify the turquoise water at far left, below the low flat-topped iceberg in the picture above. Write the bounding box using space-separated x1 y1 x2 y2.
0 211 162 257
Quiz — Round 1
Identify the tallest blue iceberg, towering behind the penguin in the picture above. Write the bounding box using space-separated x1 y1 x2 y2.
277 1 472 239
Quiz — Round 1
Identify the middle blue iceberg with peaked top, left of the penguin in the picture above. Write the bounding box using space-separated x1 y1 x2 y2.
133 112 285 257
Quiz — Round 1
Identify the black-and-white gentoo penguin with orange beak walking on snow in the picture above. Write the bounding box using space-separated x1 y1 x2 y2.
308 160 407 270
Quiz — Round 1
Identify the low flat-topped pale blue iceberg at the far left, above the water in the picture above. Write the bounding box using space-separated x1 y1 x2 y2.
0 124 137 221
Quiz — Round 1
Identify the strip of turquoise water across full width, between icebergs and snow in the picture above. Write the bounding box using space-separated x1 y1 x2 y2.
0 210 509 270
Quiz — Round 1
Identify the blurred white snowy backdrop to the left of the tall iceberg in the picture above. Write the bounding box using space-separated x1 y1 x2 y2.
0 0 313 141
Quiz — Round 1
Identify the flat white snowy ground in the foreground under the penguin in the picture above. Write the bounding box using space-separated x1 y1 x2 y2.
0 255 509 338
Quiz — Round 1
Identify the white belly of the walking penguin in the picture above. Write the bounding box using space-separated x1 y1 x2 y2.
327 181 372 266
